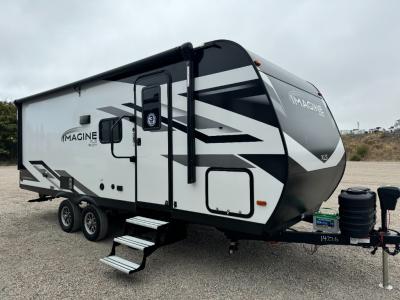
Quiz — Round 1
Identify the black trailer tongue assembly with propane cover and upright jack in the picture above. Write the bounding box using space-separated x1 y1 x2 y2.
229 186 400 290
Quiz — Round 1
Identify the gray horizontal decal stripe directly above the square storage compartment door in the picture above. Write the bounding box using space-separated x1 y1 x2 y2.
163 154 254 168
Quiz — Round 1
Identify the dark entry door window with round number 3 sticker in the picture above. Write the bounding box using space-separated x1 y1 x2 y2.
142 86 161 131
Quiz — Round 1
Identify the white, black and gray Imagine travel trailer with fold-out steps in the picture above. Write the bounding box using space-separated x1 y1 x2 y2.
15 40 400 284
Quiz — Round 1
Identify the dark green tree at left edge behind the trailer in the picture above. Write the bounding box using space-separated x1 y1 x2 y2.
0 101 17 162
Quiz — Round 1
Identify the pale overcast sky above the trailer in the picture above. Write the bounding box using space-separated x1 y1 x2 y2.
0 0 400 129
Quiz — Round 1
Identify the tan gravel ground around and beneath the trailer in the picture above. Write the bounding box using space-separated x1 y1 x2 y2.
0 162 400 299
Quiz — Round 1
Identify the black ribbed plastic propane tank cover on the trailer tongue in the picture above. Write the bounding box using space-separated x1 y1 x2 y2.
339 187 376 238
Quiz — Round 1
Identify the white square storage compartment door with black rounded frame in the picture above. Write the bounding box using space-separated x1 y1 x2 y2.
206 168 254 218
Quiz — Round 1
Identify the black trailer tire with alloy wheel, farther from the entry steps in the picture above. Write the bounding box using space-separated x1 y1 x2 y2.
58 199 82 233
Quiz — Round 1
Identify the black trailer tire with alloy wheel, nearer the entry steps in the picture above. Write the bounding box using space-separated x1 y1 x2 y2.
82 205 108 242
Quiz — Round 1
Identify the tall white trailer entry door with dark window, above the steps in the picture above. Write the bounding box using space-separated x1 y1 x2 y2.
135 74 172 205
